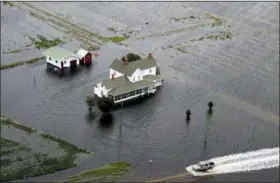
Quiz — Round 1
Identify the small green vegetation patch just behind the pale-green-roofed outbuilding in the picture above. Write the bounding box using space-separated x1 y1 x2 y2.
29 35 64 49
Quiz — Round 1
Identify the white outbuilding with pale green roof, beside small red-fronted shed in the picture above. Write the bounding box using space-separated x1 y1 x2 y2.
43 47 81 71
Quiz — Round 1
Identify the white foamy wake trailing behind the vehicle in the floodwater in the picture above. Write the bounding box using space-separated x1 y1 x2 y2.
186 147 279 176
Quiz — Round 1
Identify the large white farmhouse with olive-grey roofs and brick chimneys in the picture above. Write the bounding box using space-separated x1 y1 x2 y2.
93 53 162 103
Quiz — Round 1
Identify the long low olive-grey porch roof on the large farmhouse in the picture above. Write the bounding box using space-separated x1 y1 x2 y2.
108 80 154 96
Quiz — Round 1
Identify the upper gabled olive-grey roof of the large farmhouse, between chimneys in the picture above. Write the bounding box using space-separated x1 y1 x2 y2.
110 57 157 76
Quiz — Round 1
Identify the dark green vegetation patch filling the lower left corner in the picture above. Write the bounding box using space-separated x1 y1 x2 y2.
1 116 93 182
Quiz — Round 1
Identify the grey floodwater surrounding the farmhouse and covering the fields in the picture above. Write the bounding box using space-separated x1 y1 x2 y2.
1 2 279 181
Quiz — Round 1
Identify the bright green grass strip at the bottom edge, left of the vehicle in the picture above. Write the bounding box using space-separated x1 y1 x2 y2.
58 162 131 182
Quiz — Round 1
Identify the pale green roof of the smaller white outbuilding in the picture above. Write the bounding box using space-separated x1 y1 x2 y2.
43 47 78 59
